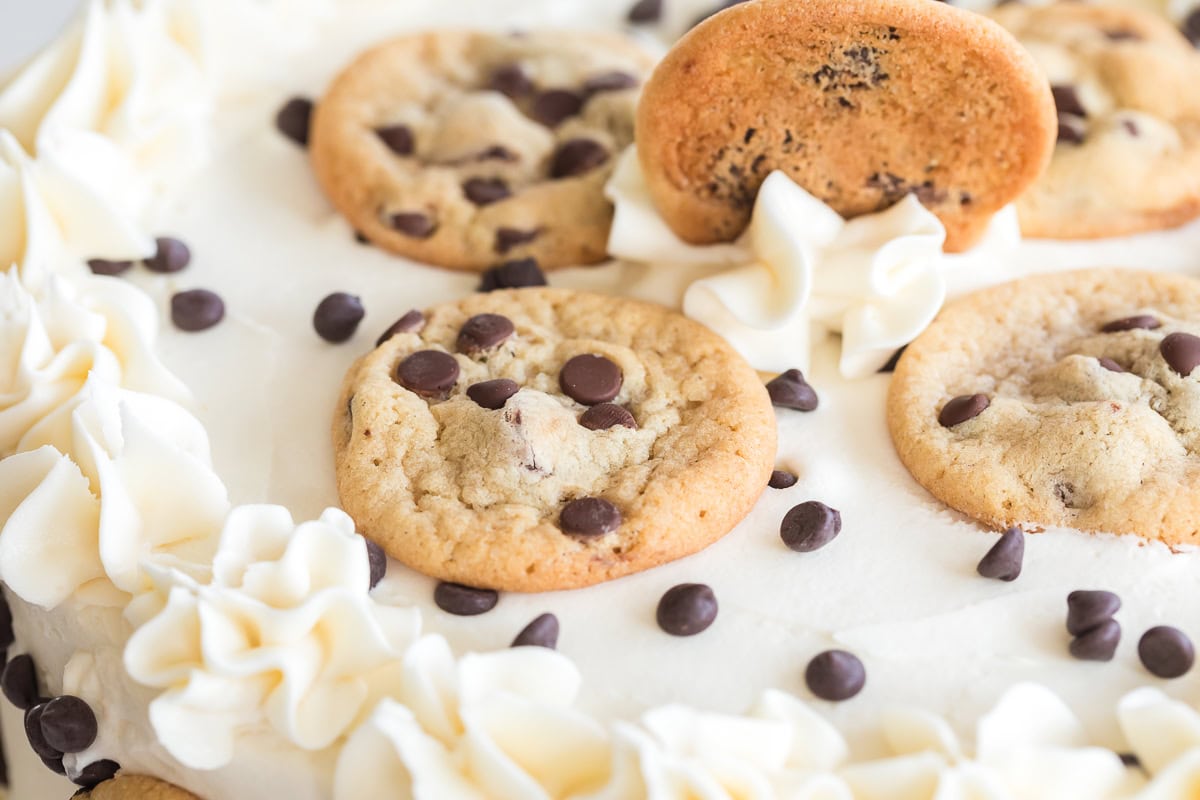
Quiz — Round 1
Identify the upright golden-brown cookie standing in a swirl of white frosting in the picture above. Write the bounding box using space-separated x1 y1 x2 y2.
637 0 1055 249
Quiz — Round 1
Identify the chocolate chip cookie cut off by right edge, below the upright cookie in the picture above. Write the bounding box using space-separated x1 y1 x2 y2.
888 270 1200 545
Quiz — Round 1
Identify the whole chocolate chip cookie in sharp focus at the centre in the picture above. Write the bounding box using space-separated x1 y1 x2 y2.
334 288 775 591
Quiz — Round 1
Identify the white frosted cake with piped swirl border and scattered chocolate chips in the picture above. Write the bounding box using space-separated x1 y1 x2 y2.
0 0 1200 800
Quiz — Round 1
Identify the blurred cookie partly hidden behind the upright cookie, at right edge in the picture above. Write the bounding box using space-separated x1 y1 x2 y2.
994 2 1200 239
